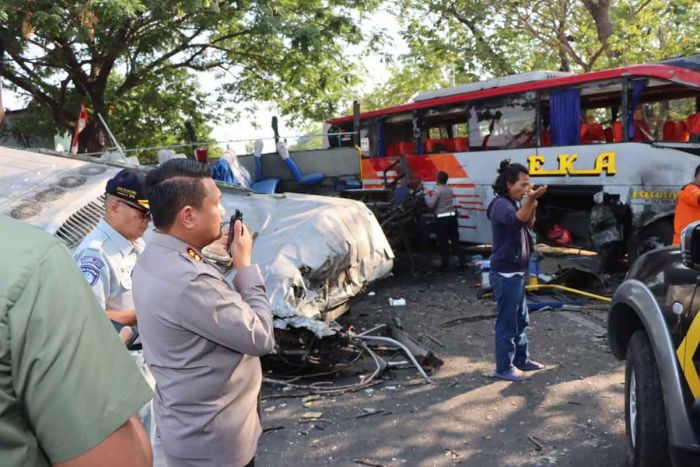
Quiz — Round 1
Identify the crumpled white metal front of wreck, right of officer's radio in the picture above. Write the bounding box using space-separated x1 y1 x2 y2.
215 189 394 330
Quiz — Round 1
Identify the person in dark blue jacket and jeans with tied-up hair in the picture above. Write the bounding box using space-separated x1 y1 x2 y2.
487 159 547 381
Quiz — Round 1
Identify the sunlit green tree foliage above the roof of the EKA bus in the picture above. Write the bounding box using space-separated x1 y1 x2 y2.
363 0 700 109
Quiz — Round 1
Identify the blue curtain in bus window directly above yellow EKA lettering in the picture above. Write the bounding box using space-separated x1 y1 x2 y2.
549 89 581 146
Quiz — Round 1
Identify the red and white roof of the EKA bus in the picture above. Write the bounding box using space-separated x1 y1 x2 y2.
328 54 700 125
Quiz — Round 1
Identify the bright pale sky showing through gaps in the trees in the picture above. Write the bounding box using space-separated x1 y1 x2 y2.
2 11 408 154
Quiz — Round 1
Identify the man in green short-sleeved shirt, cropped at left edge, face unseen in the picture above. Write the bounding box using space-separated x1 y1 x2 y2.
0 215 152 467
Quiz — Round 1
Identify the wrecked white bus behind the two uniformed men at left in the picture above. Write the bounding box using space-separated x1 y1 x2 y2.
0 147 394 337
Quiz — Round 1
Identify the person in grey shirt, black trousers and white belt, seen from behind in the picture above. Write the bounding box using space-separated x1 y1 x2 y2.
425 171 465 271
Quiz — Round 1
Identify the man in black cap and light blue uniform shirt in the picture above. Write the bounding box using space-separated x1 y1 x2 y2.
73 169 151 326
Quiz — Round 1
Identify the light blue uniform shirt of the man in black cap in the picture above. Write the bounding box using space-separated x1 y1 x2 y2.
73 219 144 310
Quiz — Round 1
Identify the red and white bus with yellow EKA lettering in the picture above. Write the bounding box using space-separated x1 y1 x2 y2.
326 54 700 255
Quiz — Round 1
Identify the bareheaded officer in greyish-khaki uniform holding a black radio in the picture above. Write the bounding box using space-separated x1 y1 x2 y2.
134 159 275 467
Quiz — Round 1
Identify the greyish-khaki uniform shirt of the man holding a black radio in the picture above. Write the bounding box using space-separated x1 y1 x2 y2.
134 232 275 466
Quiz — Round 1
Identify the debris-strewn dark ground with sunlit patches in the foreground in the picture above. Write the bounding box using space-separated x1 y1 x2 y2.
256 262 625 466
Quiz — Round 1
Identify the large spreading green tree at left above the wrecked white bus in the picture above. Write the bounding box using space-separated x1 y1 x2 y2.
0 0 378 150
